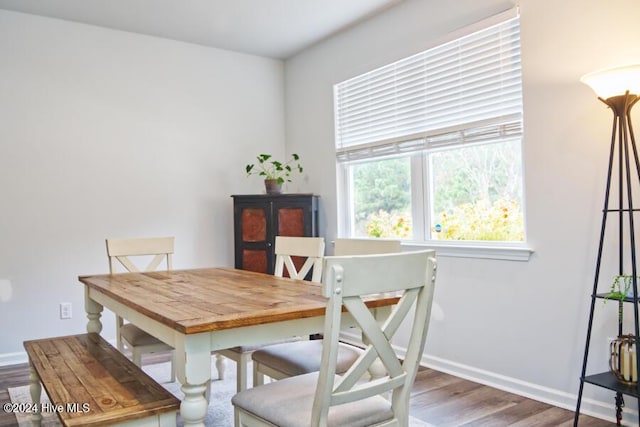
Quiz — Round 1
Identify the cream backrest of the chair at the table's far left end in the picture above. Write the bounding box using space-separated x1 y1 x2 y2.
107 237 175 274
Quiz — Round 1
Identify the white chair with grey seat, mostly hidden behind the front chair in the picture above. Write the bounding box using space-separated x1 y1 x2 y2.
251 238 401 385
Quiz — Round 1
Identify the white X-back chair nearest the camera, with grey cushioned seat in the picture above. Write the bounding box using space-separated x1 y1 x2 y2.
231 250 436 427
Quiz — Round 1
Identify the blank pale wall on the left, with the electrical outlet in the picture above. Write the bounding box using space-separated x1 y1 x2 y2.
0 11 284 364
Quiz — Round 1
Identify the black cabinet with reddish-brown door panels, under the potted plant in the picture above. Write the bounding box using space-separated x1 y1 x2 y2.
231 194 318 274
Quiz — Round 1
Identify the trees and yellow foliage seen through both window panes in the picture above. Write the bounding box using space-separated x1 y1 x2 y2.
350 140 524 242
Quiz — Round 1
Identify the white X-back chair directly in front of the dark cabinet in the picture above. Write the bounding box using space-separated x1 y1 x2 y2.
218 236 325 391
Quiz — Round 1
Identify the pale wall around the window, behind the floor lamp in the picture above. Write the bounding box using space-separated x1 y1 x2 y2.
285 0 640 422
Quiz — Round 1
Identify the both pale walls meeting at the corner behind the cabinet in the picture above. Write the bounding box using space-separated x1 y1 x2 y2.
7 0 640 417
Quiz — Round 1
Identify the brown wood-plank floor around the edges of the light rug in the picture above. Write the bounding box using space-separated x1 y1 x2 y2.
0 364 615 427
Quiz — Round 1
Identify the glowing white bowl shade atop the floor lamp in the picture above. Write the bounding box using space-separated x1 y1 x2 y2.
580 64 640 99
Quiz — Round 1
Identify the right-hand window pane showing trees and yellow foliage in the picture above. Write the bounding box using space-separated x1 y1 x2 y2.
428 141 524 242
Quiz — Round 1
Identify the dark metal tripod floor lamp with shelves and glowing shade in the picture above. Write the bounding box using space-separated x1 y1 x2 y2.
574 65 640 426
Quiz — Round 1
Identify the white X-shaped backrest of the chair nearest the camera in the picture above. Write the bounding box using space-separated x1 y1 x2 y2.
311 250 436 426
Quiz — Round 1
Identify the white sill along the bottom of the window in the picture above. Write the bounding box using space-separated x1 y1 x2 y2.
402 242 533 261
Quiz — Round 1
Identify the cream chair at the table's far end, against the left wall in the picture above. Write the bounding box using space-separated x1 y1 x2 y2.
106 237 176 382
